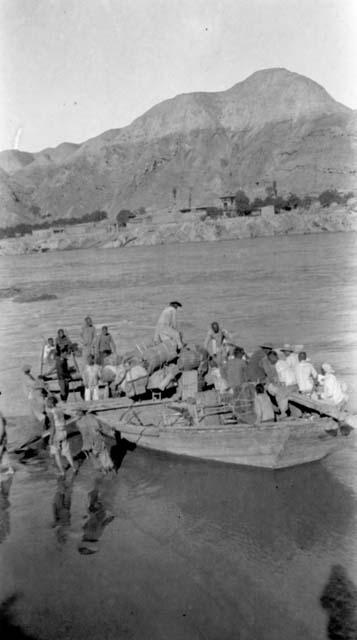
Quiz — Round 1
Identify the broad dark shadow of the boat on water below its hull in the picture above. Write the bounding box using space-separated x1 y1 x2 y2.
145 455 355 558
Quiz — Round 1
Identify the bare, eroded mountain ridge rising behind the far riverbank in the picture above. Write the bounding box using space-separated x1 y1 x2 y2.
0 69 357 226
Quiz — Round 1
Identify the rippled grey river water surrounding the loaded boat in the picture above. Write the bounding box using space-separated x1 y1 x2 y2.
0 234 357 640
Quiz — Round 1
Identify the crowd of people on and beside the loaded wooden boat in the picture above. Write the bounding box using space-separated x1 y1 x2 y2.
15 301 348 476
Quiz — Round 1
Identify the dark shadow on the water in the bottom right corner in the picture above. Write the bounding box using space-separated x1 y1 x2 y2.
320 564 357 640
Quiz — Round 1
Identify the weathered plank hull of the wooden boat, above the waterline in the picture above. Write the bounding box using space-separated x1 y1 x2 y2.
94 411 348 469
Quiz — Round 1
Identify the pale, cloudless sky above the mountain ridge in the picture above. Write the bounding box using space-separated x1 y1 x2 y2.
0 0 357 151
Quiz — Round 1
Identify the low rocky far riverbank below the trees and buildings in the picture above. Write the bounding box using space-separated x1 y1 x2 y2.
0 198 357 255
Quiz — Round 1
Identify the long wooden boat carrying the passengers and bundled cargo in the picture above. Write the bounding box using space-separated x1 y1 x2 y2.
55 392 352 469
